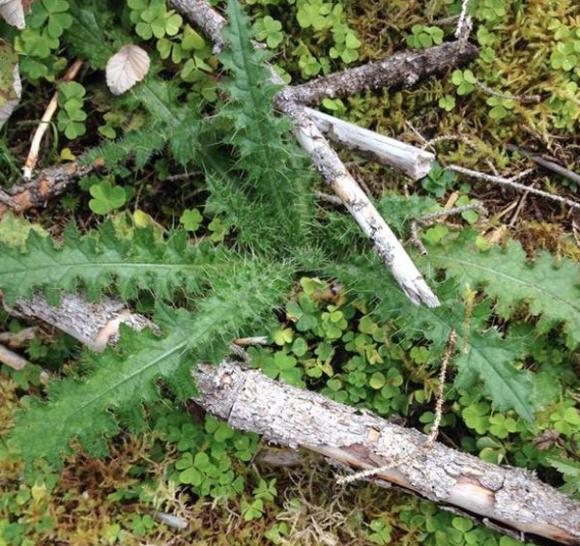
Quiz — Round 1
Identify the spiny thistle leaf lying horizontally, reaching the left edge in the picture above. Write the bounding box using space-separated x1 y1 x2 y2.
0 225 231 302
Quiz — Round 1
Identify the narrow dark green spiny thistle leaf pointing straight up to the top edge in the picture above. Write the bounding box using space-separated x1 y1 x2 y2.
212 0 312 250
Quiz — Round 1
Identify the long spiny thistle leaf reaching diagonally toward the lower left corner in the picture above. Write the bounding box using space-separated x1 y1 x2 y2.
10 261 291 466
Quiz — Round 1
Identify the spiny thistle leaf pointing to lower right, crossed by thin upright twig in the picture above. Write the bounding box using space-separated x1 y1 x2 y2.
328 257 533 419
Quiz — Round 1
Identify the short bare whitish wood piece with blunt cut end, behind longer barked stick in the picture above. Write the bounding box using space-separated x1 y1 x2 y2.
305 108 435 180
